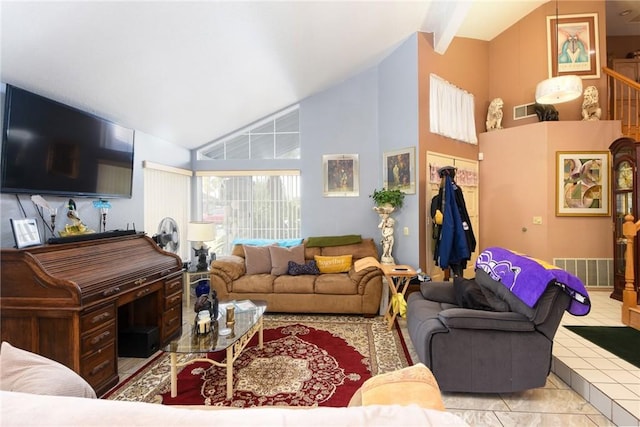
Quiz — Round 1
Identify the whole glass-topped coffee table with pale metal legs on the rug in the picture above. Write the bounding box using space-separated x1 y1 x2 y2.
163 300 267 399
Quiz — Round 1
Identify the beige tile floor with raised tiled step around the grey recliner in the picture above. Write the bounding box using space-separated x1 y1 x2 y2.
118 290 640 426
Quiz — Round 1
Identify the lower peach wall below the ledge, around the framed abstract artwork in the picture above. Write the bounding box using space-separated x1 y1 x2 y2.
479 121 621 261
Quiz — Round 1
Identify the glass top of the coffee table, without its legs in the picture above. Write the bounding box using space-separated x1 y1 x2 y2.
163 300 267 353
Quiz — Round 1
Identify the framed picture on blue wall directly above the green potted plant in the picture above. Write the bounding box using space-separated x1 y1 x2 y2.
382 147 416 194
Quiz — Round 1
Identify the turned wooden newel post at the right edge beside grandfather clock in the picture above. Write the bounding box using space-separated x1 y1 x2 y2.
622 215 640 329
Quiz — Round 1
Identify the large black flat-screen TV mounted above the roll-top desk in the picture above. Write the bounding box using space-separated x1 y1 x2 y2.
0 85 134 198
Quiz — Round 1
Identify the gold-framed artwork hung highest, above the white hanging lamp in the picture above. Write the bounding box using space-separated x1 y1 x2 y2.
547 13 600 79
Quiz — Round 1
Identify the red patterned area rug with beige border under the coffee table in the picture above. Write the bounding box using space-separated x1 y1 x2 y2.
105 314 412 407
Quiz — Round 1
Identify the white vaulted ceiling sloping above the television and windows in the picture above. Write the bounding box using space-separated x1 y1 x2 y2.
0 0 640 148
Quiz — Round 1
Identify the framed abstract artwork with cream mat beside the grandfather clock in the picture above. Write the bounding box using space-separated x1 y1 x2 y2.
556 151 610 216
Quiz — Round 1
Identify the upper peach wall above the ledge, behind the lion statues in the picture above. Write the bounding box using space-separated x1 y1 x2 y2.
487 0 607 128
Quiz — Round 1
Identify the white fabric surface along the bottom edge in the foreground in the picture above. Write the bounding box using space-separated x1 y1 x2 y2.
0 391 467 427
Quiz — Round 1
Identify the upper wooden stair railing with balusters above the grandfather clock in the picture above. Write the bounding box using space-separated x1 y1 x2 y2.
602 67 640 141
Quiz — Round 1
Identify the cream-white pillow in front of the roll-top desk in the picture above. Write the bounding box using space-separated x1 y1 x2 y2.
0 341 96 399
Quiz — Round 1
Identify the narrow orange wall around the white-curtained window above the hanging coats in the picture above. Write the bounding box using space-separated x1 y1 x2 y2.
417 33 489 266
